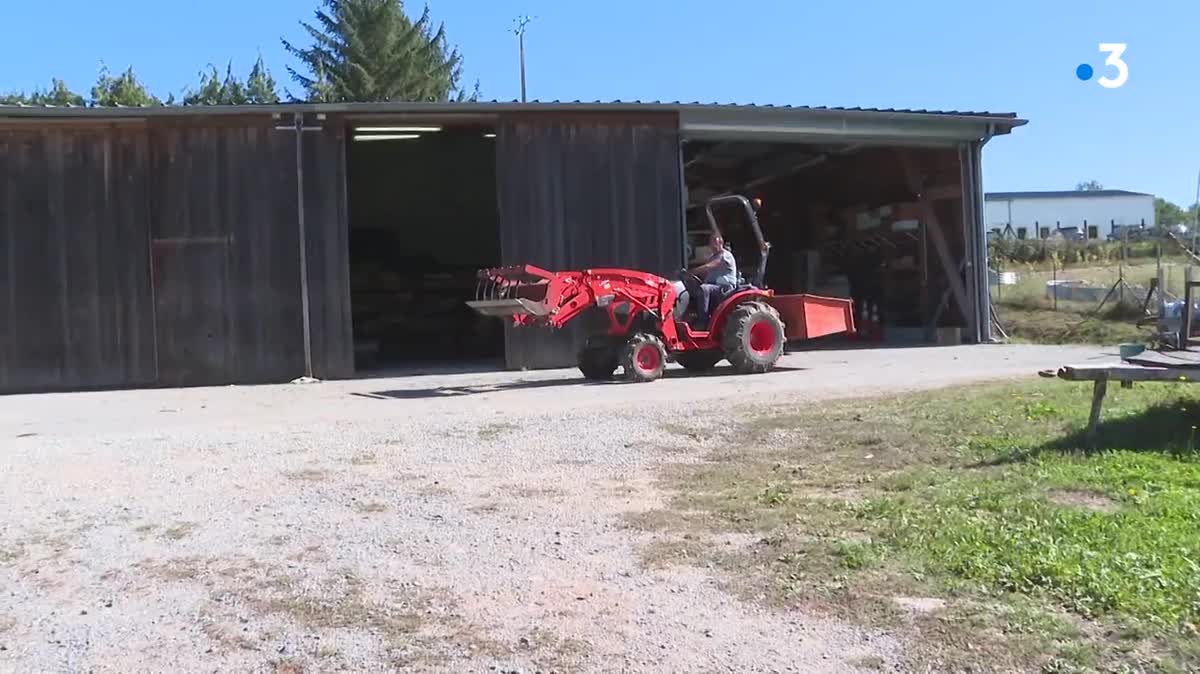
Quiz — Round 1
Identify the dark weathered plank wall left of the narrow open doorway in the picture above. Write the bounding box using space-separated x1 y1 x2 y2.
0 115 354 391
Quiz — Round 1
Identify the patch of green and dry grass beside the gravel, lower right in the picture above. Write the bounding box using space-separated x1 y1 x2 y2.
640 380 1200 672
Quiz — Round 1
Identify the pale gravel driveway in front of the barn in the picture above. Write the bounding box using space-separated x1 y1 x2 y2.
0 345 1100 673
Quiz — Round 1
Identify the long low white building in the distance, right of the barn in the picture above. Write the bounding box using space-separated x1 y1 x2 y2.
984 189 1154 239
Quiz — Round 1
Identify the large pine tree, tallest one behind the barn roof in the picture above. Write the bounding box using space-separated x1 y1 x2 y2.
283 0 479 102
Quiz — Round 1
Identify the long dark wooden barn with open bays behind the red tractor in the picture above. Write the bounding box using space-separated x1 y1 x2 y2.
0 103 1024 392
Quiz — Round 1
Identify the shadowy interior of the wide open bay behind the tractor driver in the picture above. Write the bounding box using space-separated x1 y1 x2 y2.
684 140 966 343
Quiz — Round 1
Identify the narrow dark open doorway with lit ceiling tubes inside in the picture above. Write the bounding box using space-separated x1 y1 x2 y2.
347 122 504 373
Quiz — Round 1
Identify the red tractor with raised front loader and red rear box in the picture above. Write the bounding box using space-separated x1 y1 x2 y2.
467 195 854 381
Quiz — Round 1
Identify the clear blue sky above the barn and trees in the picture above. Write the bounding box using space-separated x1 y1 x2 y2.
0 0 1200 205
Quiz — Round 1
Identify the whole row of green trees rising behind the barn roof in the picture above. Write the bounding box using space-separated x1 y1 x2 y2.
0 0 479 107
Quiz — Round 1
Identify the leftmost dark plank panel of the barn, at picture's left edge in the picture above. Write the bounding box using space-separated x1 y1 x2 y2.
0 127 155 391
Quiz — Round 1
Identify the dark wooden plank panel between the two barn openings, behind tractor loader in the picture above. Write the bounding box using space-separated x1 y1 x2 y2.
497 114 684 368
